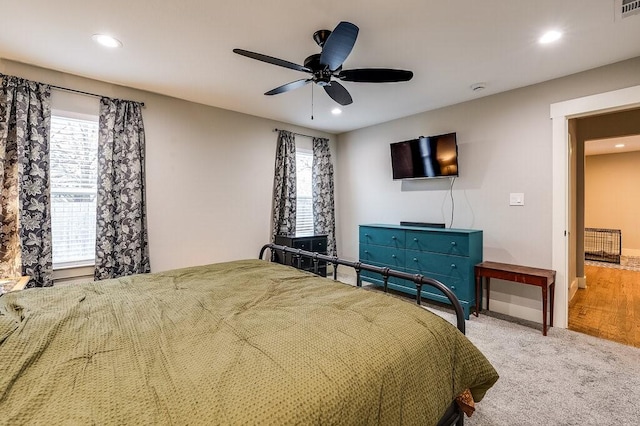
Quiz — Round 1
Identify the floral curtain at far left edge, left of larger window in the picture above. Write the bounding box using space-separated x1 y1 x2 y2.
0 75 53 287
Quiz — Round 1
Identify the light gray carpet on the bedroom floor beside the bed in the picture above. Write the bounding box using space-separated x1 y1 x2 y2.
429 308 640 426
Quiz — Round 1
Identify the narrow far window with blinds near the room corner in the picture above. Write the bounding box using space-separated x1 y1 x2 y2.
296 148 313 235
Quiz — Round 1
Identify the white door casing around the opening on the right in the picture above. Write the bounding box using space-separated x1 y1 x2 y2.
550 86 640 328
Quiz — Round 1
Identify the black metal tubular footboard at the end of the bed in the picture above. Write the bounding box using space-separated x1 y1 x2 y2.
258 244 465 334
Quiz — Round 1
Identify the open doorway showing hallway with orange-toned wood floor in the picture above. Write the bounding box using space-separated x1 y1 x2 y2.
568 125 640 347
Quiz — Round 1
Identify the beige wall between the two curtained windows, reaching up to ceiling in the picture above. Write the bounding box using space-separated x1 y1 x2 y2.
0 60 335 272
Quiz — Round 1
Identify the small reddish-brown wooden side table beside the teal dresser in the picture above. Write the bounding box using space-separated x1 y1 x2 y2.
475 262 556 336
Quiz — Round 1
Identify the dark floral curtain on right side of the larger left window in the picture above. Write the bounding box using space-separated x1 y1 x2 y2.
94 98 151 280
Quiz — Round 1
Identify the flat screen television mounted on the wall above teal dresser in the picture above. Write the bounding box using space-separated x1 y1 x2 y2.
391 132 458 180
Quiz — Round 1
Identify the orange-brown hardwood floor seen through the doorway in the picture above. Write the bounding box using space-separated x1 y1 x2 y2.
569 265 640 347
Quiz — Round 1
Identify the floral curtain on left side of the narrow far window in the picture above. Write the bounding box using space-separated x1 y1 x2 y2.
271 130 296 241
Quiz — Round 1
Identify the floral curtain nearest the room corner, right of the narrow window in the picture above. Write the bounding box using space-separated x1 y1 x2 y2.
312 138 338 256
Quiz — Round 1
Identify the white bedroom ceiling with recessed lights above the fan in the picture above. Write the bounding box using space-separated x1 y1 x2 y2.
0 0 640 133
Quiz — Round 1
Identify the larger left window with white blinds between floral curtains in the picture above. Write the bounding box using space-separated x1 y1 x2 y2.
50 114 98 269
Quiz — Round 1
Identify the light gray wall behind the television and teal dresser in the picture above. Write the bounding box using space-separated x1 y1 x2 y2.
336 58 640 322
